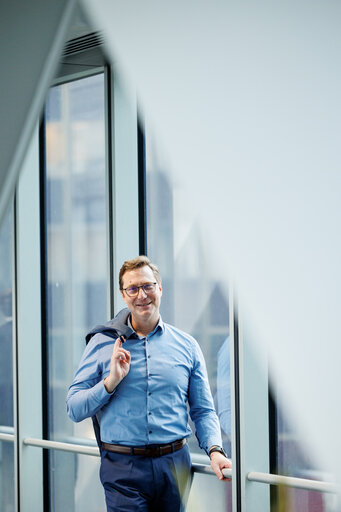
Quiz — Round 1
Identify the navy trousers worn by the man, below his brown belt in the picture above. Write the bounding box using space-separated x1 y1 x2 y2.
100 444 192 512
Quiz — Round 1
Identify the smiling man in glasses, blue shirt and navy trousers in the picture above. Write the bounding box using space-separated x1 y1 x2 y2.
67 256 231 512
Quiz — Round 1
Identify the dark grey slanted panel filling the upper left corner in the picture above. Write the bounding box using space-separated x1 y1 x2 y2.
0 0 76 222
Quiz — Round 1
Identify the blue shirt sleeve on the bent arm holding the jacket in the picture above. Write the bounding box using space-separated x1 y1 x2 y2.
66 334 113 422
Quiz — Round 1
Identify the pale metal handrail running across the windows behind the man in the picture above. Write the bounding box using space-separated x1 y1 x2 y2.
21 434 339 493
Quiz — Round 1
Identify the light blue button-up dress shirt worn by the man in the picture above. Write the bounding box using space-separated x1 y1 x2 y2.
67 318 222 451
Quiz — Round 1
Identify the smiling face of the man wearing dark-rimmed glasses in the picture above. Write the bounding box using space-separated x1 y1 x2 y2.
121 265 162 323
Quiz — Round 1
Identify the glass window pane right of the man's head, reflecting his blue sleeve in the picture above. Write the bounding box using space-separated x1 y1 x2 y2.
145 131 232 510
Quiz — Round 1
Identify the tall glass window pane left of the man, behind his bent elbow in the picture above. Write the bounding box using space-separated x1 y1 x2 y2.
45 74 108 512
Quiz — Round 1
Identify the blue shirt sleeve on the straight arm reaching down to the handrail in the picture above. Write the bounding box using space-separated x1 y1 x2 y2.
188 342 222 453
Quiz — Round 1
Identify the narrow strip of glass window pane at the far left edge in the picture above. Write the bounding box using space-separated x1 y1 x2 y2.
0 209 14 512
